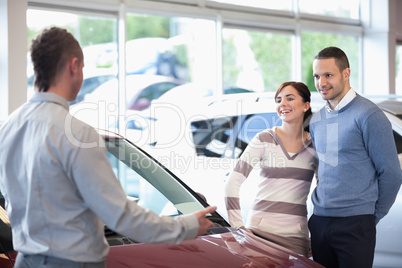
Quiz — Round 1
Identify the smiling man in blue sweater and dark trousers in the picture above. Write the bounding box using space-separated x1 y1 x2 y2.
309 47 402 268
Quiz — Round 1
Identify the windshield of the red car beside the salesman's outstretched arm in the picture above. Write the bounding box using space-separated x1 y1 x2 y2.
105 138 204 216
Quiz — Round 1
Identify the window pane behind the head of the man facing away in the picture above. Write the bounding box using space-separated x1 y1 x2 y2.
27 9 117 96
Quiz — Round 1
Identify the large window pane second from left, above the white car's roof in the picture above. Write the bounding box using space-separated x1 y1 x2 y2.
126 13 216 110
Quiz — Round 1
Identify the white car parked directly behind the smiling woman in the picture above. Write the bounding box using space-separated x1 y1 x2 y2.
121 92 322 218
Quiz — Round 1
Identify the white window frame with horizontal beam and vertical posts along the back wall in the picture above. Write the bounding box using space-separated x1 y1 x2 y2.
6 0 367 123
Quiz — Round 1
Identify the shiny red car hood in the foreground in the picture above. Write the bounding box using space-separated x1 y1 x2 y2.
107 230 322 268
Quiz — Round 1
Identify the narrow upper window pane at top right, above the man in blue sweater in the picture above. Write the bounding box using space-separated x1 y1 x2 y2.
299 0 360 19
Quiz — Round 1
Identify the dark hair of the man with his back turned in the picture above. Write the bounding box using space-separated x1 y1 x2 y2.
31 27 83 92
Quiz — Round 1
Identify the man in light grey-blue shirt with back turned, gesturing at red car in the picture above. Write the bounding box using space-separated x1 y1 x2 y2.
0 27 216 268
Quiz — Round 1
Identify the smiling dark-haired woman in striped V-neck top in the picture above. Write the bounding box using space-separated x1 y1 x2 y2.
225 82 317 257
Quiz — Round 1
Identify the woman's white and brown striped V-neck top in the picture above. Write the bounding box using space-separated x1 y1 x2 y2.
225 129 317 256
